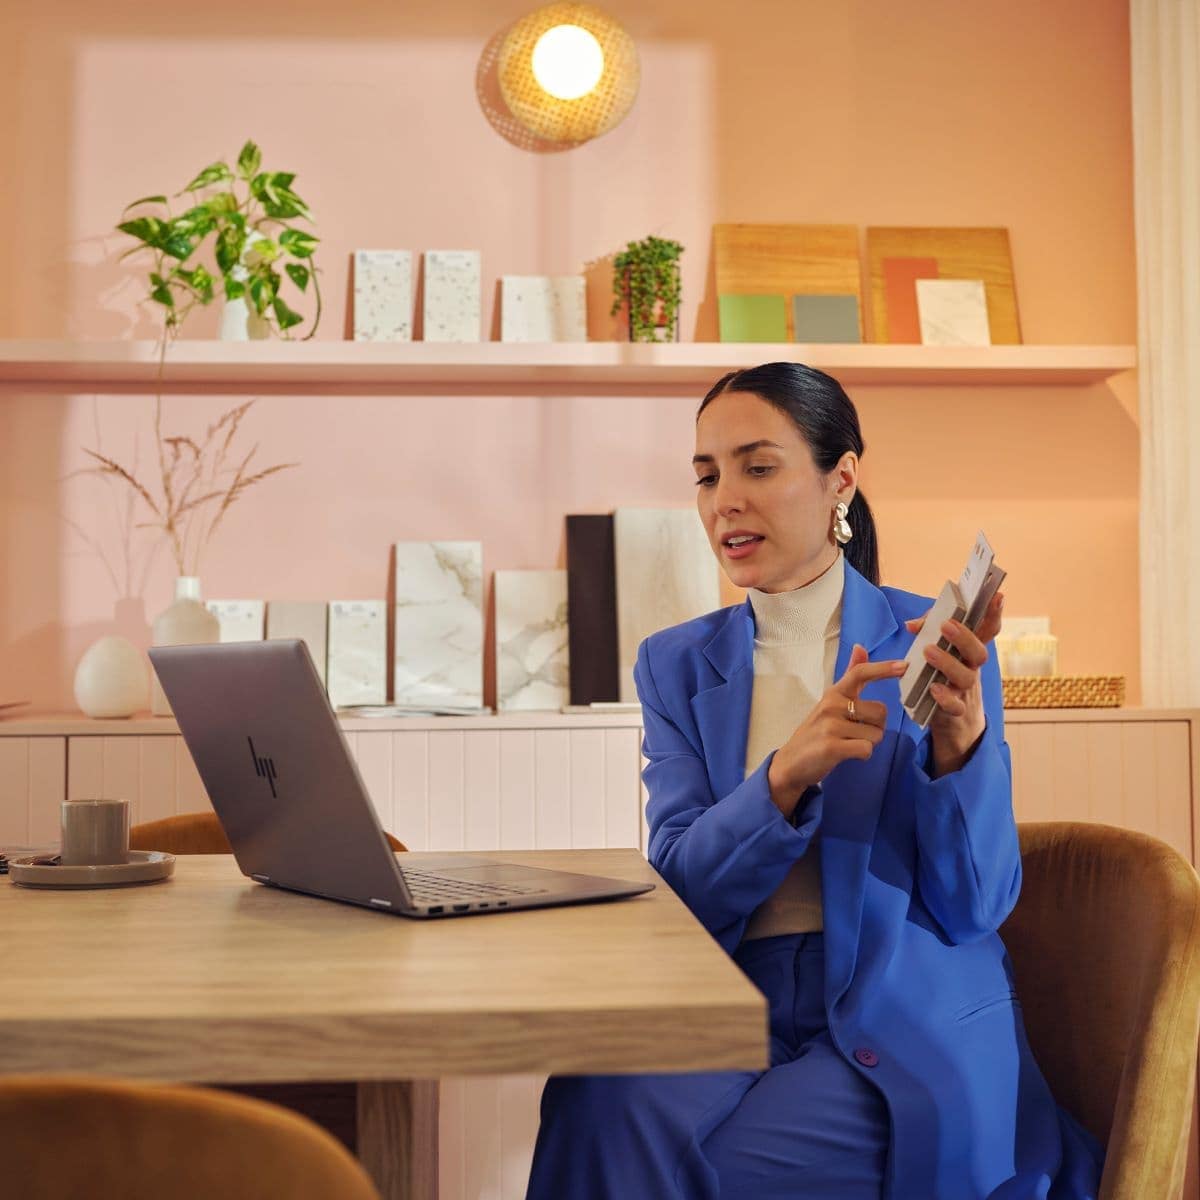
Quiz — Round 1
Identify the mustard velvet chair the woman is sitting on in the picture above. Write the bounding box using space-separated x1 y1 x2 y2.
1001 822 1200 1200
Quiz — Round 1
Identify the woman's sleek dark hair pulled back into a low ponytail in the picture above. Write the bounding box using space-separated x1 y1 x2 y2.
696 362 880 587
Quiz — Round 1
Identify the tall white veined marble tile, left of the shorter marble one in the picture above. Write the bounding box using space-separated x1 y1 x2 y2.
392 541 484 708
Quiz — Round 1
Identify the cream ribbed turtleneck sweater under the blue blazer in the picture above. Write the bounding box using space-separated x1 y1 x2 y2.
744 553 846 940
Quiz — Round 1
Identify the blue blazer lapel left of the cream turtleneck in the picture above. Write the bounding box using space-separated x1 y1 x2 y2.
691 600 754 799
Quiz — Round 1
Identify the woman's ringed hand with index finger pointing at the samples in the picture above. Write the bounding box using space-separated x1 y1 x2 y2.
767 646 905 818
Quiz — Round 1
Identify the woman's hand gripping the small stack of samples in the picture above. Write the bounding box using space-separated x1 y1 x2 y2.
905 592 1004 779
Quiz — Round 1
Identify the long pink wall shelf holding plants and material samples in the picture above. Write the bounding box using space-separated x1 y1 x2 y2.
0 340 1136 396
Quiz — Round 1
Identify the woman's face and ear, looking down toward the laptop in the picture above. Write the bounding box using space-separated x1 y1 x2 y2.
692 391 858 592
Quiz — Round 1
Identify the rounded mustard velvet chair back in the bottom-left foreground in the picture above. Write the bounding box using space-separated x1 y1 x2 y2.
0 1076 379 1200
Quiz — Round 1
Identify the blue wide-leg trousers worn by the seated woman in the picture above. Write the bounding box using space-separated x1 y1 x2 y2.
527 934 888 1200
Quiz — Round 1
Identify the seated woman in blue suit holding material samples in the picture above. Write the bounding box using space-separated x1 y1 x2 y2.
528 362 1100 1200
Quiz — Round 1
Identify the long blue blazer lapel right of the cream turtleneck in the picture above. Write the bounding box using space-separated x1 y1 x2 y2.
821 563 904 1008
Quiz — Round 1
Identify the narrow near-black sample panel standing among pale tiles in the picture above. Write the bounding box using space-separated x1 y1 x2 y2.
566 515 620 704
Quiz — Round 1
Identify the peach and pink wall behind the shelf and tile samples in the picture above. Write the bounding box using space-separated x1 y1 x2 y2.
0 0 1138 708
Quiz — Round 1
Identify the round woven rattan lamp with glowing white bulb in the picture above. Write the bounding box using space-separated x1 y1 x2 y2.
496 0 641 149
